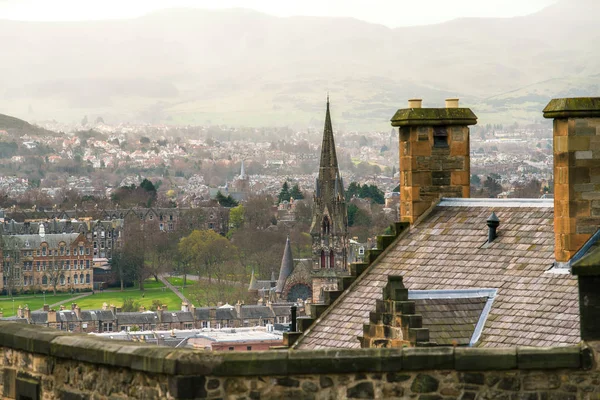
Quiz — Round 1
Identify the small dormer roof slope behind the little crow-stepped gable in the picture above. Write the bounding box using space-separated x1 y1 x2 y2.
415 297 487 346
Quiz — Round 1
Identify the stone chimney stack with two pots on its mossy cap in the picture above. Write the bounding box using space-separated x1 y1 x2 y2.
392 99 477 224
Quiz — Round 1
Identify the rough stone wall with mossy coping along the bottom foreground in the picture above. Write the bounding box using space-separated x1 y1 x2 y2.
0 322 600 400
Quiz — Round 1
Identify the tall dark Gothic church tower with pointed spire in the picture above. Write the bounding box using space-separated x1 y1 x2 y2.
310 96 348 302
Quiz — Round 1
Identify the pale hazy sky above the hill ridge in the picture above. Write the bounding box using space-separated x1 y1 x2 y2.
0 0 557 27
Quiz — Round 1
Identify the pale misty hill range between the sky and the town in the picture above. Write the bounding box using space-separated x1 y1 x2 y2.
0 0 600 129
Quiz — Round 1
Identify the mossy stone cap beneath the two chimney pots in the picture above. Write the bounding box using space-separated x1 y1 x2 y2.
391 108 477 126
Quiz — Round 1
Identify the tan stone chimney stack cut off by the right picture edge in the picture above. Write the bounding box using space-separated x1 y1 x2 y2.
544 97 600 263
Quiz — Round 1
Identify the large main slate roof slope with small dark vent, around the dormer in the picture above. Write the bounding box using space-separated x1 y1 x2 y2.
295 200 579 349
